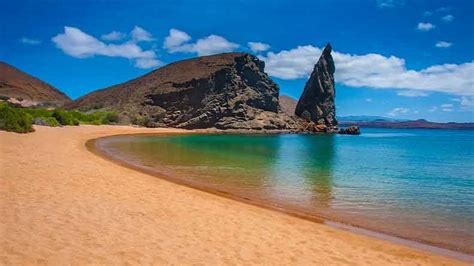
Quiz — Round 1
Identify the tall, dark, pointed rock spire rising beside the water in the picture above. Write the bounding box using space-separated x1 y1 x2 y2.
295 44 337 131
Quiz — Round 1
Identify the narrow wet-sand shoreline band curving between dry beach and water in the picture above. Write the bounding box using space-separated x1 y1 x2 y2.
91 134 474 262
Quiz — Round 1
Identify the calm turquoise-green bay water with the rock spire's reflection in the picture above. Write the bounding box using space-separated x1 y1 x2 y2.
97 129 474 254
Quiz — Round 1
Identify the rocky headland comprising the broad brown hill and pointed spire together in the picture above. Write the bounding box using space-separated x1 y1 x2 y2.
66 44 348 132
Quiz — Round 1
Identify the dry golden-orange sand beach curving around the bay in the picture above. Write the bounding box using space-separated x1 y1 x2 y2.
0 126 466 265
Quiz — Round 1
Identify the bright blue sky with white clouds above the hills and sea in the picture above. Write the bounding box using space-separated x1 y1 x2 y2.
0 0 474 122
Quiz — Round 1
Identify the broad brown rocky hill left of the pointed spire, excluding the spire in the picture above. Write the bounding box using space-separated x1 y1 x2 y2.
67 53 296 130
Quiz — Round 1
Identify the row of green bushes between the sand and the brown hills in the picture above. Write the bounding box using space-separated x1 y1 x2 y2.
0 102 119 133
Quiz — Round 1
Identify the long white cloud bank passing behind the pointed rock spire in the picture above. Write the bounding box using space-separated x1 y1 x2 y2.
260 45 474 96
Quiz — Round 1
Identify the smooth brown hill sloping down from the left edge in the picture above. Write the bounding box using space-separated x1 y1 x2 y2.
0 62 71 105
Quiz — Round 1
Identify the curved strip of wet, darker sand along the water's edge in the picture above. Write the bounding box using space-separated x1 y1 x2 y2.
89 131 474 262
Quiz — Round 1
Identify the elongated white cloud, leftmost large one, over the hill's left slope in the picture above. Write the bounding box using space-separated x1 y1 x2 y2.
52 27 160 67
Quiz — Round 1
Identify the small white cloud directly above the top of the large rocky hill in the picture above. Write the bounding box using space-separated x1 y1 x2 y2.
163 29 239 56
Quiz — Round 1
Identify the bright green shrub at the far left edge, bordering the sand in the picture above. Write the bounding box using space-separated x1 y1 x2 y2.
0 104 34 133
